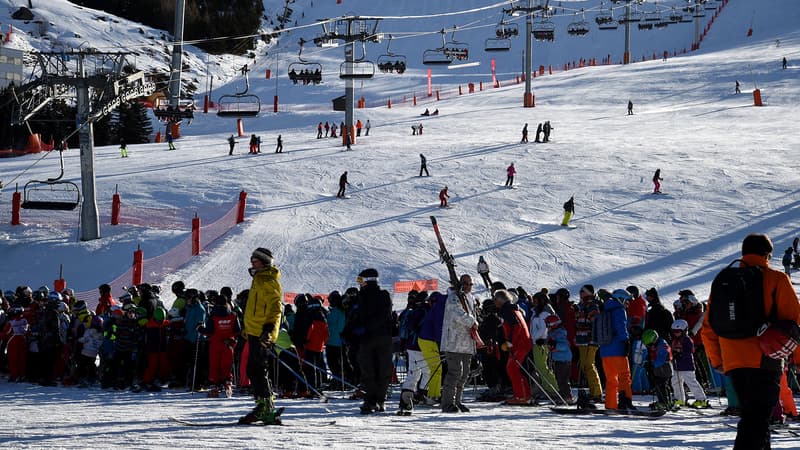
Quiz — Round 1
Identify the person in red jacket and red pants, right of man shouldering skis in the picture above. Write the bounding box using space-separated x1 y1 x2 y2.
492 289 533 405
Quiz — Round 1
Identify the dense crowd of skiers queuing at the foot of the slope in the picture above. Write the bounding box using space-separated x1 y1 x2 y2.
0 237 800 438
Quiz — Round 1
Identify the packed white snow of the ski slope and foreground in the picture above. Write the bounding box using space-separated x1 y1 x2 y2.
0 0 800 449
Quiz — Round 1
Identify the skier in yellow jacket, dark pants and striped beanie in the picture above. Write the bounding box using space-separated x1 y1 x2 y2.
239 247 283 425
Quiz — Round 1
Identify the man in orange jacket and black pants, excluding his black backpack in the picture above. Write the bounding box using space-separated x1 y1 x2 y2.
701 234 800 450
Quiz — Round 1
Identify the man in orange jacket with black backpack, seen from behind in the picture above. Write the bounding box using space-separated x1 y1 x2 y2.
701 234 800 450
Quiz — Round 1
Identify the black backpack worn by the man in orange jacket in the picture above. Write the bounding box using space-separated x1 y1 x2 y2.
708 259 767 339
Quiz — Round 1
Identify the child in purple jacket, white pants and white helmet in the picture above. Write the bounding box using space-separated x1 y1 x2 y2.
672 319 708 408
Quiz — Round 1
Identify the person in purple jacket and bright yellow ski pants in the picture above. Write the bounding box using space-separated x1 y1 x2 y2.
417 292 447 400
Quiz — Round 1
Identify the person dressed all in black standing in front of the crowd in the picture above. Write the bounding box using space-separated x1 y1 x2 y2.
353 268 394 414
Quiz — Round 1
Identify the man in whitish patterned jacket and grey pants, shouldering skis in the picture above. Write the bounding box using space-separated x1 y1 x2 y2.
441 274 478 413
